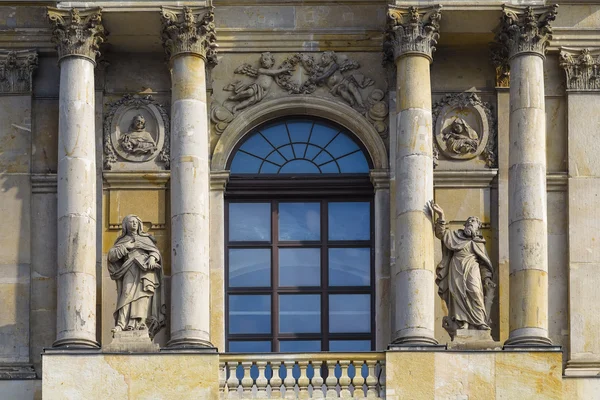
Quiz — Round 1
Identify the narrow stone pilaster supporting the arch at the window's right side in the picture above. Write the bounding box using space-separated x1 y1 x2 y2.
371 169 392 350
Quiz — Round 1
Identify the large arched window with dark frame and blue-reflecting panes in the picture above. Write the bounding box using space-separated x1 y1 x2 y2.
225 118 375 352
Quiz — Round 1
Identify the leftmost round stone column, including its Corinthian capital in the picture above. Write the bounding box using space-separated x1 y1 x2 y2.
48 8 105 348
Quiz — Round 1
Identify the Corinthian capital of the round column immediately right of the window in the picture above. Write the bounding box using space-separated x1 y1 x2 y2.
384 6 442 61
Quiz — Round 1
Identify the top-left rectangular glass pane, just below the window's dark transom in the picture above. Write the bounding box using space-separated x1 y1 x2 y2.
229 203 271 242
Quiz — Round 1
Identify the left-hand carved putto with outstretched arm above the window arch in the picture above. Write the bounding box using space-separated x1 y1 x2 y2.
224 52 291 114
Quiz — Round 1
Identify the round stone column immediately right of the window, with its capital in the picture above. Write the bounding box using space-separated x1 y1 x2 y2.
386 6 441 345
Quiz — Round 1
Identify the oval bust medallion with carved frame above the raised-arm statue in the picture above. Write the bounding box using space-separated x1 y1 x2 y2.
433 93 496 168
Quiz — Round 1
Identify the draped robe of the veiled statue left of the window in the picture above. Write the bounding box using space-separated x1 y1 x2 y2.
108 235 165 336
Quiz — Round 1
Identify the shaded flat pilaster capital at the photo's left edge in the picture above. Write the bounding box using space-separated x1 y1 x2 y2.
0 50 38 93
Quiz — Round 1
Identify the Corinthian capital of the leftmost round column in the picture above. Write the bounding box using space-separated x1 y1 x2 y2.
48 7 106 62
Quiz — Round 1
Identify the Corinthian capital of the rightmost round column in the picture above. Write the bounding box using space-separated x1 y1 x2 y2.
496 5 558 59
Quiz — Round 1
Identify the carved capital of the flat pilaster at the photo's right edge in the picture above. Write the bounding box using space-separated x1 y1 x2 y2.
560 47 600 91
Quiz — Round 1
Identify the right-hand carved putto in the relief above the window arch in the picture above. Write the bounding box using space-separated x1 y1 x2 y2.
303 51 373 111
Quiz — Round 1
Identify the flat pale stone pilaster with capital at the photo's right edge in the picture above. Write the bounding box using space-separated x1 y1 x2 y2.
560 48 600 376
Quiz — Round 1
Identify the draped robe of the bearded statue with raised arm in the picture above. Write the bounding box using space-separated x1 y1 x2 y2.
435 219 494 328
